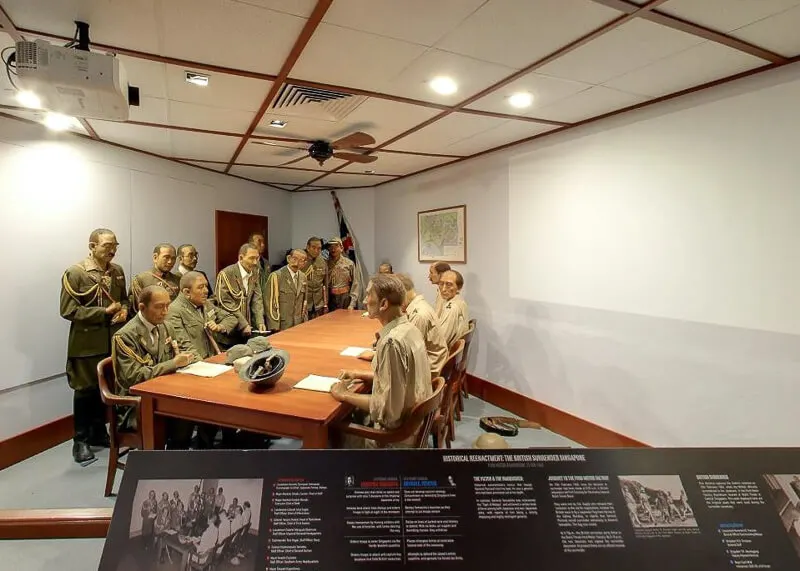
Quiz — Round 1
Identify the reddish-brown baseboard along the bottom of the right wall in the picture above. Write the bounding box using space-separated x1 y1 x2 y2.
467 374 649 448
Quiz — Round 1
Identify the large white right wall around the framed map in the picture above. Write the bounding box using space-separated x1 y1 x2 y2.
375 61 800 446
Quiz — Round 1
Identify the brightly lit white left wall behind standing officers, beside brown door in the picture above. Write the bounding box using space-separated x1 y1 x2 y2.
0 119 291 439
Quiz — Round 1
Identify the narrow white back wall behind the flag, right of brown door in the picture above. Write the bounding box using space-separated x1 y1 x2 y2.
292 188 382 274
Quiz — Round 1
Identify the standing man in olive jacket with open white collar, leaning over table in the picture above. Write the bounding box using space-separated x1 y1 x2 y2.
216 244 266 337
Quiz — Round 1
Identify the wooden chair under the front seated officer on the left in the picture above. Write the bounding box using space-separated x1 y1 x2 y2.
97 357 142 497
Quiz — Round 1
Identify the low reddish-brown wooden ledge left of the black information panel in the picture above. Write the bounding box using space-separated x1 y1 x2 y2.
0 508 113 540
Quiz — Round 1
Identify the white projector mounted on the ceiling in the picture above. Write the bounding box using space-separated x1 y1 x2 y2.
15 40 139 121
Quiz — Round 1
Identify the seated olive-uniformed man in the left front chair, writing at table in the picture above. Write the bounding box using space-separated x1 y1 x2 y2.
111 286 195 438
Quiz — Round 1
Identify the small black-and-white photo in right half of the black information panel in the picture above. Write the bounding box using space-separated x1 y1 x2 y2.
619 475 697 528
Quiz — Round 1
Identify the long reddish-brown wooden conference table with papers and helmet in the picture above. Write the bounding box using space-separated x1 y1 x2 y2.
131 310 379 450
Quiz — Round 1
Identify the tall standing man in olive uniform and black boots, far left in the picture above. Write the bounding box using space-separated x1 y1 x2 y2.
60 228 128 463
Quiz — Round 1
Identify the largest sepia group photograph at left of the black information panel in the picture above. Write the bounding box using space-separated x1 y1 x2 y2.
118 479 264 571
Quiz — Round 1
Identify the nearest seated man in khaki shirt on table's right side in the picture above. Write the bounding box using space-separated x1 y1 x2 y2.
331 274 433 448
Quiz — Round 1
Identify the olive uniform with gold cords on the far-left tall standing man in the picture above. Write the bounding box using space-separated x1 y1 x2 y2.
60 256 128 442
